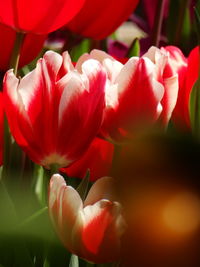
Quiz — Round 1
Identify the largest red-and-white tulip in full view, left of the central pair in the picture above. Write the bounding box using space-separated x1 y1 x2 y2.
4 51 106 168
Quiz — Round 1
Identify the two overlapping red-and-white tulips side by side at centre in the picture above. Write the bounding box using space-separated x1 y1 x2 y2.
4 47 178 168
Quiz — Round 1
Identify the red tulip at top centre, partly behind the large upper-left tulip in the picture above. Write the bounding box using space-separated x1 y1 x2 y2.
67 0 139 40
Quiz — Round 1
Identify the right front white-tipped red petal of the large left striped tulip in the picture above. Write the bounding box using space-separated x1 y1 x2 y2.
58 60 106 161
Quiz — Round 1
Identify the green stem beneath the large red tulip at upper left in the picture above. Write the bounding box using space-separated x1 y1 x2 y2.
10 32 25 75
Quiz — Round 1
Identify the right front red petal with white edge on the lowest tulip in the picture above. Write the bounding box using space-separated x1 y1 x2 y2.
72 200 125 263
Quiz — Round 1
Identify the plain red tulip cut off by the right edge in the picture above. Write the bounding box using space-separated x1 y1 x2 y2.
172 47 200 129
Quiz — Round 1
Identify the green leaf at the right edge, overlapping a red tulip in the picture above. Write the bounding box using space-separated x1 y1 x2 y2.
189 78 200 138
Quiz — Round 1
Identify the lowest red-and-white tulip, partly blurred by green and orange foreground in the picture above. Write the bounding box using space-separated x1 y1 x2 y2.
49 174 125 263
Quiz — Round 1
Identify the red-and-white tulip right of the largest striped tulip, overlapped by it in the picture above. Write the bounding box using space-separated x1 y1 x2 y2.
77 47 178 142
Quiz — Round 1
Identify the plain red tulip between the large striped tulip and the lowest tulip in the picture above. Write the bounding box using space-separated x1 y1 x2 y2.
62 138 114 181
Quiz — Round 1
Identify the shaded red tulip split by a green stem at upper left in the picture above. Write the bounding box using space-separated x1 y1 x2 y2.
0 24 47 71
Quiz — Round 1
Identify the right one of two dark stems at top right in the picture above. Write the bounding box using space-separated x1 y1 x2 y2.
174 0 190 45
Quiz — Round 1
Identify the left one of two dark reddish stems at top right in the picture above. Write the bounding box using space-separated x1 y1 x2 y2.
152 0 165 46
